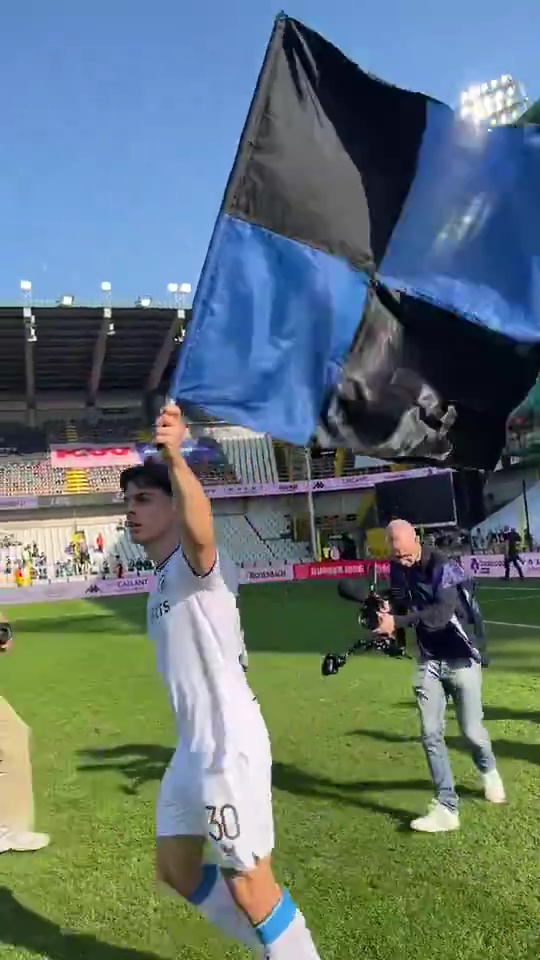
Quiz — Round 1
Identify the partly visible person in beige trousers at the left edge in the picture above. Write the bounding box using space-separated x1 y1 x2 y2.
0 613 49 853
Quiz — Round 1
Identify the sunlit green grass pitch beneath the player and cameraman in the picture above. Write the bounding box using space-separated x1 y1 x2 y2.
0 584 540 960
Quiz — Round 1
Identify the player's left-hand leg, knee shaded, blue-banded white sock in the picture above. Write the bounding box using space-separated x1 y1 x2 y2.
156 837 263 956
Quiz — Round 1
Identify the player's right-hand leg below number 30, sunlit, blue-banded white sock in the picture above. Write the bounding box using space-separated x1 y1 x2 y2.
224 857 319 960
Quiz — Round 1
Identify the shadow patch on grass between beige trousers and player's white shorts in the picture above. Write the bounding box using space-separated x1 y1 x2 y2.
79 743 174 794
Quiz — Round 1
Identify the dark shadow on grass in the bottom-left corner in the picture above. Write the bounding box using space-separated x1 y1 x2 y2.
0 887 159 960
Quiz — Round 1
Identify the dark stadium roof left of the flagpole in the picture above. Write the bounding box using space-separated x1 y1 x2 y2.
0 305 191 402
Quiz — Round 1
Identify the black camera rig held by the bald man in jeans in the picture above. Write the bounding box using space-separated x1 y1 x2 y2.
321 580 411 677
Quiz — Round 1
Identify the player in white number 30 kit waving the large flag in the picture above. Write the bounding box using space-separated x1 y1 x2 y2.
121 403 319 960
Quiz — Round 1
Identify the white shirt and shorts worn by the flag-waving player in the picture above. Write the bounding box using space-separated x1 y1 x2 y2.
148 548 274 870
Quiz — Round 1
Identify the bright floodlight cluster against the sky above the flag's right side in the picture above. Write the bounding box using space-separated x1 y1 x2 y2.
459 73 528 127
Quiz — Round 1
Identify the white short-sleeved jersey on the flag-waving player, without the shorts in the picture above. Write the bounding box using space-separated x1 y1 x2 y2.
148 547 269 769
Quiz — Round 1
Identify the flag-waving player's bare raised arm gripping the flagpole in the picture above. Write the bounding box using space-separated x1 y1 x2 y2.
155 403 216 577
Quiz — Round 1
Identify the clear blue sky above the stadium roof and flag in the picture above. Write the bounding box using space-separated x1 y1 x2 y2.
0 0 540 303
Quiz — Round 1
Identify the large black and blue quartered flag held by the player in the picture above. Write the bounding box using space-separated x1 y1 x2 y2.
171 16 540 468
